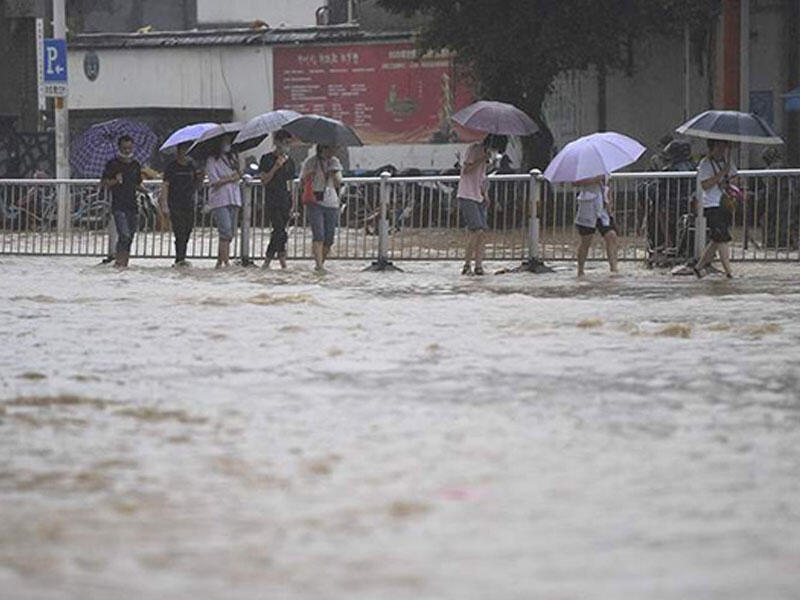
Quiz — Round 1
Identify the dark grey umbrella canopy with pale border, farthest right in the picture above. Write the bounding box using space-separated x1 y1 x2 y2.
675 110 783 144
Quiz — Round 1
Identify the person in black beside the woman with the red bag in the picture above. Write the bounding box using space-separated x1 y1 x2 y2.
258 129 296 269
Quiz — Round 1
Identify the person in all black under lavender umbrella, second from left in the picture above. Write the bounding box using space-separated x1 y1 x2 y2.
160 142 203 267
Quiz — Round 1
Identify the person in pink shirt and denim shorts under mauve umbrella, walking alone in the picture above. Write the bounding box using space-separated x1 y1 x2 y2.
458 135 508 275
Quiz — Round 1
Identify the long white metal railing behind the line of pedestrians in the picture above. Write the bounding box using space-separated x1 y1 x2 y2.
0 169 800 265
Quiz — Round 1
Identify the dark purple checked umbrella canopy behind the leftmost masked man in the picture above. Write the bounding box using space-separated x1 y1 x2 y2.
69 119 158 178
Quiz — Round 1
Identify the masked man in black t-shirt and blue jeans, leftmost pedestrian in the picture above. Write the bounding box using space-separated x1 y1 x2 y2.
102 135 147 268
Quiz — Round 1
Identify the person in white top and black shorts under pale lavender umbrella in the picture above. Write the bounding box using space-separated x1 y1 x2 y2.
575 175 617 277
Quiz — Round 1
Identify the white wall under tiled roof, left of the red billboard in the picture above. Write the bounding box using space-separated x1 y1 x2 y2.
69 46 273 121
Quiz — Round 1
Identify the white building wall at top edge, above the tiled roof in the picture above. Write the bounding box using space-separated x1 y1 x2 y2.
197 0 327 27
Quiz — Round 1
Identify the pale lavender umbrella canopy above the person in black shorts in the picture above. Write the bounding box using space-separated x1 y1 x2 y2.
544 131 646 183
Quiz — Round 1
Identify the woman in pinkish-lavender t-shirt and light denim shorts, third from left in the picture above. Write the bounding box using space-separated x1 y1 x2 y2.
206 135 242 269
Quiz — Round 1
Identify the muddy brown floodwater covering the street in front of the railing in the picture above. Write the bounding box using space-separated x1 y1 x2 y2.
0 257 800 600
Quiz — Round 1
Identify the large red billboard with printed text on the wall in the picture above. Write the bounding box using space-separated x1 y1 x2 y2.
273 42 473 144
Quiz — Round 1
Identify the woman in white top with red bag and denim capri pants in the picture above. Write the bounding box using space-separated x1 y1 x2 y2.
300 144 342 273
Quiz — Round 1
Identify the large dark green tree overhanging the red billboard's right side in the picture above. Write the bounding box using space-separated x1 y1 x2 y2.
378 0 721 168
